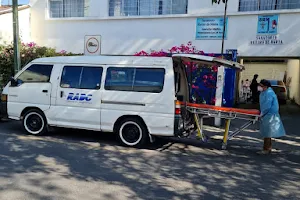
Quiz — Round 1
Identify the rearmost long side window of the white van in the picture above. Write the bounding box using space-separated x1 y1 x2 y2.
105 67 165 93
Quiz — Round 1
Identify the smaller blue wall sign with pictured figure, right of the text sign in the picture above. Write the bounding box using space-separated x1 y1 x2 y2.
257 15 278 35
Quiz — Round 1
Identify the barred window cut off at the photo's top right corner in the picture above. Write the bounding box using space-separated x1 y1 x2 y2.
239 0 300 11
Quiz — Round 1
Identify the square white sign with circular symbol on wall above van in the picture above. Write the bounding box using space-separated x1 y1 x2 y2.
84 35 101 56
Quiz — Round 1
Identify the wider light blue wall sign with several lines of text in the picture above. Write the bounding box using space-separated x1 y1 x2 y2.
196 17 228 40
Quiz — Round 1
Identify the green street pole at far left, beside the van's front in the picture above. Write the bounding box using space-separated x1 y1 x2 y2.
12 0 21 74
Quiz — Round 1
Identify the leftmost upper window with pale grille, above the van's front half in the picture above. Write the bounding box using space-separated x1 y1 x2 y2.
49 0 88 18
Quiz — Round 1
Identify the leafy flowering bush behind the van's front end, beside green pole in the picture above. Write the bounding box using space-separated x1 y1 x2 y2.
0 42 75 89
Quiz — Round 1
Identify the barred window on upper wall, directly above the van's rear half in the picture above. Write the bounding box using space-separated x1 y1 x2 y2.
109 0 188 16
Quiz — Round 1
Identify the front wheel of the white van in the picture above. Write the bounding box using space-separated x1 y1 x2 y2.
22 109 48 136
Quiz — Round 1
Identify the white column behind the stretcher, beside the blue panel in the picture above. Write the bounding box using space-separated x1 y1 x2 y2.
215 66 225 126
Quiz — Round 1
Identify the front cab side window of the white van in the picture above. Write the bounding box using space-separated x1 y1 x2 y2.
17 64 53 84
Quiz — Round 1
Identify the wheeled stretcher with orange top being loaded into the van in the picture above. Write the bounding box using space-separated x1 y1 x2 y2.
178 102 260 149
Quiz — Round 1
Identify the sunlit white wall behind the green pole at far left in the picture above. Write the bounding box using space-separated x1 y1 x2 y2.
0 8 31 44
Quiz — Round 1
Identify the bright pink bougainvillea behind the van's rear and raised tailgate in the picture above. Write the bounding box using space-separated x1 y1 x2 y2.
135 42 218 105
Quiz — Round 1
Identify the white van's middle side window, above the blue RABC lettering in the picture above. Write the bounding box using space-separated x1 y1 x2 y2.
60 66 103 89
